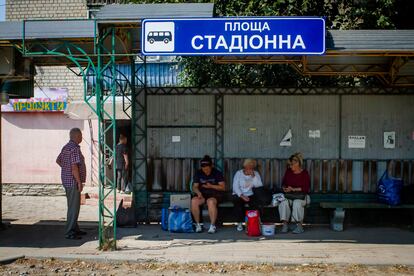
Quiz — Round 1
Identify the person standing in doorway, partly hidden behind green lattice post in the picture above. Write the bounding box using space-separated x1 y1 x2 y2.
115 134 129 193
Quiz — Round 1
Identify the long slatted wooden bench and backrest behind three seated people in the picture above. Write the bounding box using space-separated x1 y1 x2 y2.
146 158 414 224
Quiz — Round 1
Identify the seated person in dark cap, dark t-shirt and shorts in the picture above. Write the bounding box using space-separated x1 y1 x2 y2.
191 155 226 234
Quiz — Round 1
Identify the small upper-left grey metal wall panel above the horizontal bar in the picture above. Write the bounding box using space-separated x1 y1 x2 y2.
147 95 214 126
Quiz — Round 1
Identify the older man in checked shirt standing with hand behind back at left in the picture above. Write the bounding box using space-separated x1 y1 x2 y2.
56 128 86 240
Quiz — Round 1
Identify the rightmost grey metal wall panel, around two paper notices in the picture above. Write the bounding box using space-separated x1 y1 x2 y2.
341 95 414 159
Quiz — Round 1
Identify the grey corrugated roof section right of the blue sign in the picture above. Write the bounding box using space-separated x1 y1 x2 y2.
326 30 414 51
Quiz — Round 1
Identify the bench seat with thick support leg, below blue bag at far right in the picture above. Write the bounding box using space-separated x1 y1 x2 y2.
319 201 414 231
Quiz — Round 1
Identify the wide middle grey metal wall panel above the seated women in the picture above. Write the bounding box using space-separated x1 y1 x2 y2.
224 95 339 159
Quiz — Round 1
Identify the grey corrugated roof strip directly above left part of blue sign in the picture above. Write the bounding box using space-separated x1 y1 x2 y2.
96 3 214 20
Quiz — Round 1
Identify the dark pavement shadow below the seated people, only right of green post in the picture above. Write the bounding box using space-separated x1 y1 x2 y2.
117 225 414 248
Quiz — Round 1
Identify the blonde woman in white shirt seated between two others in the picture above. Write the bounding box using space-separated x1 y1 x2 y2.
233 159 263 231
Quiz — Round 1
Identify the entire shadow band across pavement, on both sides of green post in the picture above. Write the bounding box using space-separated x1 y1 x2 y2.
0 221 414 249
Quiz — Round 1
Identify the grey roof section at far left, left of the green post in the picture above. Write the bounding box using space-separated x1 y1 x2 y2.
0 20 95 40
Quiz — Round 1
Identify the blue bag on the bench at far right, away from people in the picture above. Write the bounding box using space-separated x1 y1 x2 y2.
377 170 403 205
